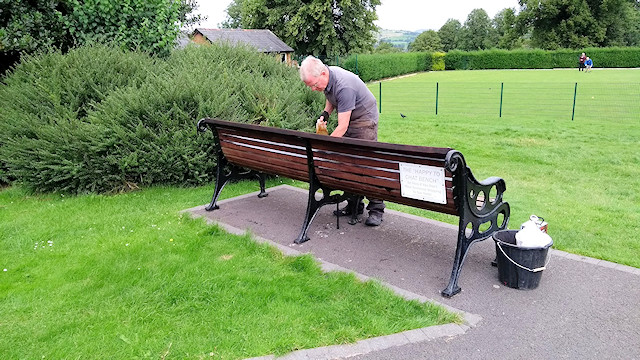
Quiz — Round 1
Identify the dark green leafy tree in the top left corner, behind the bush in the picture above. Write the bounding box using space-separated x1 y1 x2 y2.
0 0 200 73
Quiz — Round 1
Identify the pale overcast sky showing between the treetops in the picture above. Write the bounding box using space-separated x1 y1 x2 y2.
196 0 520 31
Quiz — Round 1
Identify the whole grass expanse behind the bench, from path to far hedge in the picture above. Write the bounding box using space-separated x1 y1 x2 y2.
369 69 640 267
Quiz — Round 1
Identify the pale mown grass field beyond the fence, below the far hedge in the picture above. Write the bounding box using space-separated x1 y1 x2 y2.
370 69 640 123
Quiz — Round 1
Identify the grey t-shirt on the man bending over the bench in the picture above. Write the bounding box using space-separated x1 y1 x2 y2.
324 66 378 126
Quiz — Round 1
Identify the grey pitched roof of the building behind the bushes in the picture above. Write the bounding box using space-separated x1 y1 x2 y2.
194 28 293 53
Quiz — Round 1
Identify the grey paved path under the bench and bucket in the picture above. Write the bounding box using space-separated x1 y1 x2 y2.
189 185 640 360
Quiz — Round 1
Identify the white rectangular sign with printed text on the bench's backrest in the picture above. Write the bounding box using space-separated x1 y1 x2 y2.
400 162 447 204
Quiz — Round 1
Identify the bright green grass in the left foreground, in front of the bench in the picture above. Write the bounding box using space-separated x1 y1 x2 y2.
0 180 460 359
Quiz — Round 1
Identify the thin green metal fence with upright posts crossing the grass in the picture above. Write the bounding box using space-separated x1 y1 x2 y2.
370 82 640 121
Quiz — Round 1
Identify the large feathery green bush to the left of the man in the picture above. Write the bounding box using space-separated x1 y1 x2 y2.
0 45 324 193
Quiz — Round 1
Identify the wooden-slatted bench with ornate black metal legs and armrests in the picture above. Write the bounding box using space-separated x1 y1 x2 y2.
197 118 510 297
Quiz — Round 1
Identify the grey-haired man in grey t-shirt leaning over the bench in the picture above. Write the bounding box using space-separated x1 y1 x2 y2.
300 56 385 226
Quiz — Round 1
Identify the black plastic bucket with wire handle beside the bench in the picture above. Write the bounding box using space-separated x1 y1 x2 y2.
493 230 553 290
